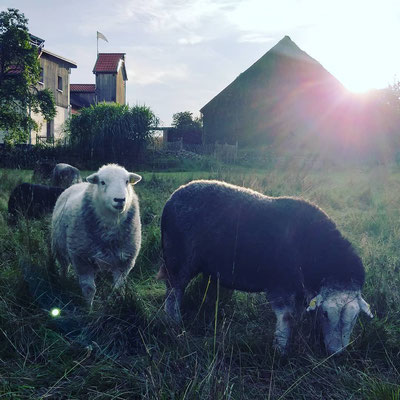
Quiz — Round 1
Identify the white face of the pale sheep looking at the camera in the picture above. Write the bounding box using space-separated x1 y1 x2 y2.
86 164 142 213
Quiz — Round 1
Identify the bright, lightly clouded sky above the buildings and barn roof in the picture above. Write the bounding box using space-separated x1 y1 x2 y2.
0 0 400 126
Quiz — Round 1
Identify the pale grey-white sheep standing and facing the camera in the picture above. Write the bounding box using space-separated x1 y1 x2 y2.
52 164 141 306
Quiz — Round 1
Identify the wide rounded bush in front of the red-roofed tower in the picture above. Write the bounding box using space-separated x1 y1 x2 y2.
67 103 158 163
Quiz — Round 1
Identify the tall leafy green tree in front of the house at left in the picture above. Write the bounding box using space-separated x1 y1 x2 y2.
0 8 56 144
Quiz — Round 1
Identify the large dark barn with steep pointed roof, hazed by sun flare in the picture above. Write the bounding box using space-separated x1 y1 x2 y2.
200 36 393 158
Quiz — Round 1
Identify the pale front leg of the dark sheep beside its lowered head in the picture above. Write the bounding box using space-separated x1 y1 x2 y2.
271 301 294 354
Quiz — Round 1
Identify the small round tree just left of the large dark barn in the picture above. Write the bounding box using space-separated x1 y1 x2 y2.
171 111 203 144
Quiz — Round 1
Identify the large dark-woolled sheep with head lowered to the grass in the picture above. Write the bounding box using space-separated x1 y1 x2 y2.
158 181 372 353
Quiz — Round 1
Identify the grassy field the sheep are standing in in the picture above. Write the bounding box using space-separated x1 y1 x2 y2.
0 166 400 400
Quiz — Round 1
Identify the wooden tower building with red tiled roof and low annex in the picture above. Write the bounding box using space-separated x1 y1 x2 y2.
71 53 128 113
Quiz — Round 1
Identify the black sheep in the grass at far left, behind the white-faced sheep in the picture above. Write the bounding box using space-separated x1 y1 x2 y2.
8 183 64 223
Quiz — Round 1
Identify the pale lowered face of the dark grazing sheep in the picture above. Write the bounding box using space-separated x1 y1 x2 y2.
308 290 373 354
